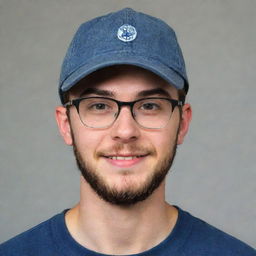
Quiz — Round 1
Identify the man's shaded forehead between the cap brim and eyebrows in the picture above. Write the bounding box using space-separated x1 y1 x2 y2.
69 65 178 98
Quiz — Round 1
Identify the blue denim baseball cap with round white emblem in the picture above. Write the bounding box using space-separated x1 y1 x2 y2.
59 8 188 103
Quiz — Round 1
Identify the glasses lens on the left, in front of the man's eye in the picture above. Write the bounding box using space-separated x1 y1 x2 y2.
79 97 118 128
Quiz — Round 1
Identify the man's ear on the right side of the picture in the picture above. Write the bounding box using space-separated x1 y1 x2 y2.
177 104 192 145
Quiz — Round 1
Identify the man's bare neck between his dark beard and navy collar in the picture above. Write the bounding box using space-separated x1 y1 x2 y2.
66 179 178 255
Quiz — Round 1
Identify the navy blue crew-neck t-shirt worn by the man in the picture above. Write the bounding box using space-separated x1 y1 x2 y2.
0 209 256 256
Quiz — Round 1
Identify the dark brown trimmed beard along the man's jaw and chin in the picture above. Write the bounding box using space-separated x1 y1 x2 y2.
72 133 178 206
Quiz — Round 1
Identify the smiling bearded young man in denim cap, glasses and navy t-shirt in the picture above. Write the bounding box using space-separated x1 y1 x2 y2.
0 8 256 256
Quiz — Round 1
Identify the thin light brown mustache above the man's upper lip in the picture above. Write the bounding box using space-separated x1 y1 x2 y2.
96 143 156 157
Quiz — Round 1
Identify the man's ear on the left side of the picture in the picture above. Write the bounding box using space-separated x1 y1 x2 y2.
55 106 73 145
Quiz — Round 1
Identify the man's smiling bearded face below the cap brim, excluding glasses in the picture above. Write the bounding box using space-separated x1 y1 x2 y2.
56 67 192 205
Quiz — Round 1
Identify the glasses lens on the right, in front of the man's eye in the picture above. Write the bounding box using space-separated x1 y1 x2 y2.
133 98 172 129
